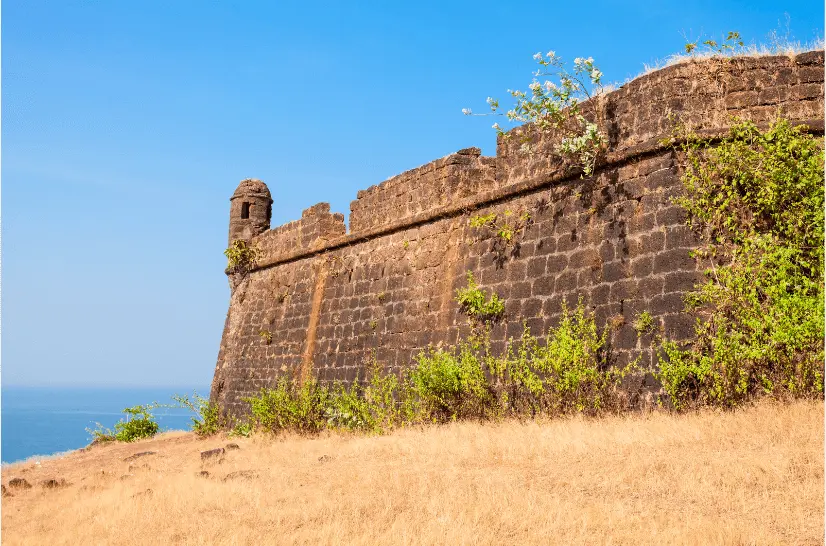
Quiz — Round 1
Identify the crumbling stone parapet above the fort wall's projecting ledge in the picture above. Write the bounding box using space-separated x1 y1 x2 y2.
243 51 824 266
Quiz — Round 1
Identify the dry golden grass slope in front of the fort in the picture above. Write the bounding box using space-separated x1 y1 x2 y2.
2 402 824 546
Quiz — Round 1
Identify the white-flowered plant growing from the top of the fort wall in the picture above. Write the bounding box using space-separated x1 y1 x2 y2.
462 51 607 176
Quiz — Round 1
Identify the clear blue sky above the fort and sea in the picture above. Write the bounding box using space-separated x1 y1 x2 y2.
2 0 824 386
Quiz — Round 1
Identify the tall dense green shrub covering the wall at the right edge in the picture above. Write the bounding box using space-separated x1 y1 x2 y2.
659 121 824 408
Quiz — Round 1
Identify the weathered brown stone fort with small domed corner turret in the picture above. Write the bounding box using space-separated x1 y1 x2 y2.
211 51 824 415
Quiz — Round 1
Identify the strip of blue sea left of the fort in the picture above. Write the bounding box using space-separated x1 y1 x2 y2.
0 385 209 464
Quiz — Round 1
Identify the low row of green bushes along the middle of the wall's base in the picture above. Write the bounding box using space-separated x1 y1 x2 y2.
241 302 636 434
